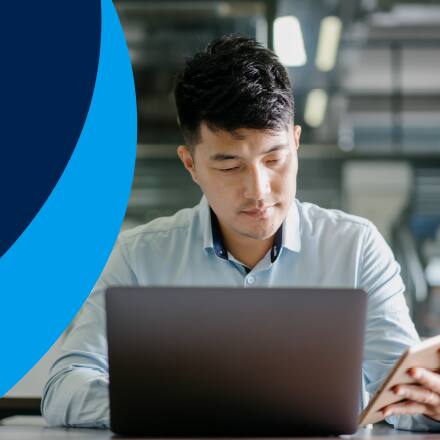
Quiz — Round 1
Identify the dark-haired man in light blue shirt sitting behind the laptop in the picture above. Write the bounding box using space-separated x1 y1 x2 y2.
42 36 440 430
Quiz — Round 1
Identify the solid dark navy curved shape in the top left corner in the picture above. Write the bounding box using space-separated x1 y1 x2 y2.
0 0 101 258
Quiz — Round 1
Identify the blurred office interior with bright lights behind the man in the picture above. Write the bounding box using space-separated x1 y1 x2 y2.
3 0 440 412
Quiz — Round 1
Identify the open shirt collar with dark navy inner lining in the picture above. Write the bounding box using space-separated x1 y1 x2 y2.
199 196 301 263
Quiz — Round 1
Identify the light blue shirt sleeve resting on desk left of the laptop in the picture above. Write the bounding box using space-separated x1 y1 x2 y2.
41 235 138 428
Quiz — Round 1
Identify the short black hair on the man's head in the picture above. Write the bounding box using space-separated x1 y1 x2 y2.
174 35 294 146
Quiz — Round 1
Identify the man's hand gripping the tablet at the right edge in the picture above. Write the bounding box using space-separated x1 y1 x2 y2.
382 368 440 422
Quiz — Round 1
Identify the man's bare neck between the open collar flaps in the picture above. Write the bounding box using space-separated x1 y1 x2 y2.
220 225 274 269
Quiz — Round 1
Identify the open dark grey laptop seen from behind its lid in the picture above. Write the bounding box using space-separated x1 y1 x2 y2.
106 287 367 437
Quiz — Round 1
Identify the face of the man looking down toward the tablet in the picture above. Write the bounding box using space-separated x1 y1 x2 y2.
178 124 301 240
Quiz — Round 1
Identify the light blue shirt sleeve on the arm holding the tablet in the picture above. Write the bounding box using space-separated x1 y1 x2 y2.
359 225 440 431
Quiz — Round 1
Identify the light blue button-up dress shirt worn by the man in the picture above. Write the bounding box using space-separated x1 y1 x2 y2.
42 197 440 431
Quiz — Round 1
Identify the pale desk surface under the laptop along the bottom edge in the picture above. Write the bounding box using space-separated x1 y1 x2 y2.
0 417 440 440
